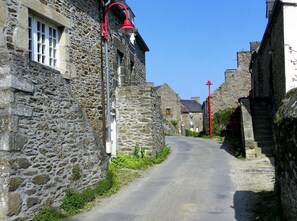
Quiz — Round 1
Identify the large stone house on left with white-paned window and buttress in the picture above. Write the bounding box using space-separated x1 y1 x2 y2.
0 0 164 221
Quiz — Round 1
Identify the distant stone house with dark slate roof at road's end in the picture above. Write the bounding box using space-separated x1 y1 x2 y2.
180 97 203 134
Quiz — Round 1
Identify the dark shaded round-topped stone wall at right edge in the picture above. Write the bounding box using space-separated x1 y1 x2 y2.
274 89 297 221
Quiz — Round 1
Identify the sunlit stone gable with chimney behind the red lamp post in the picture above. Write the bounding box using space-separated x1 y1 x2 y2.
211 51 251 114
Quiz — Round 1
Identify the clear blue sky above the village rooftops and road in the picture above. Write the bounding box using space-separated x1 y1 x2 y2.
126 0 267 103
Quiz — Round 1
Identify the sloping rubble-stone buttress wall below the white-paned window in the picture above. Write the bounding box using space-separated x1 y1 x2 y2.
0 52 108 220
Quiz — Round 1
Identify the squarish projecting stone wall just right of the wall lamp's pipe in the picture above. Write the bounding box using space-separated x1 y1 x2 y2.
116 84 164 155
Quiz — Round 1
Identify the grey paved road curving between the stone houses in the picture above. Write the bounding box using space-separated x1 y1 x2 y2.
66 137 238 221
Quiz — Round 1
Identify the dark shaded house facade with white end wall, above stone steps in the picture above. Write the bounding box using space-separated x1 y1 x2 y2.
251 0 297 109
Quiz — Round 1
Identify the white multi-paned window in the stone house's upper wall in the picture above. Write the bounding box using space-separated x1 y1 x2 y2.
28 15 59 68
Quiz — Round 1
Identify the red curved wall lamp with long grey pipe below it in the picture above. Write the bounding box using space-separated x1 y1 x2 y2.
101 2 137 155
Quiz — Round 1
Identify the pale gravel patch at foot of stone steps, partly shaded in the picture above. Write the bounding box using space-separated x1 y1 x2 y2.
230 157 275 221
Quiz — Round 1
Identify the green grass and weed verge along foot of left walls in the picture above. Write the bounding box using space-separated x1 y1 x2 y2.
33 145 170 221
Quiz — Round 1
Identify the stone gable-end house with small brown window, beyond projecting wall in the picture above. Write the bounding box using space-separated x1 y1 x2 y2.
154 83 181 135
